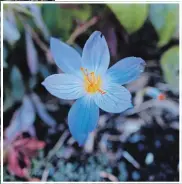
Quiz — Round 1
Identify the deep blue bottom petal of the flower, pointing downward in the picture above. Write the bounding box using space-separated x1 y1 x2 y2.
68 96 99 145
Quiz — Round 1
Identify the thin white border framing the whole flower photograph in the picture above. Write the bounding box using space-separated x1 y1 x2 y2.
1 0 182 184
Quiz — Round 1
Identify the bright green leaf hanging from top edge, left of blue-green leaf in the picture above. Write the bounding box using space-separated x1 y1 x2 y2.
108 4 148 33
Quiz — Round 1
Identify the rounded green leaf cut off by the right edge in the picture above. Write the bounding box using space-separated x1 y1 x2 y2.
160 46 179 93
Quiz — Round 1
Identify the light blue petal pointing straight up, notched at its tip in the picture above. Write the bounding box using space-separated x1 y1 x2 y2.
82 31 110 75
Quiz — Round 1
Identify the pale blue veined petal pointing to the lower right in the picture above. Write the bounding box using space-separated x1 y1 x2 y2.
94 83 133 113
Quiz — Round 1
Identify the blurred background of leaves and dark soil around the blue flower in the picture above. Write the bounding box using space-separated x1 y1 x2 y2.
1 4 179 181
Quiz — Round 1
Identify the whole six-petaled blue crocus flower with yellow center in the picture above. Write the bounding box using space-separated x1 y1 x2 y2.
43 31 145 145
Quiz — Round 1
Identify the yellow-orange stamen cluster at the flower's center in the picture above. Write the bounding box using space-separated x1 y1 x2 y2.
80 67 106 94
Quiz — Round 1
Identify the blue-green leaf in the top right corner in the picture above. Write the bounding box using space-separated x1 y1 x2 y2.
149 4 179 47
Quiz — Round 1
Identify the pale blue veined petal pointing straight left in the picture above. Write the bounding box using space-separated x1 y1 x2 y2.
42 74 85 100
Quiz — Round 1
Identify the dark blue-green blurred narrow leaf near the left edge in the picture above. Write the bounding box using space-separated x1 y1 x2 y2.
10 66 25 101
